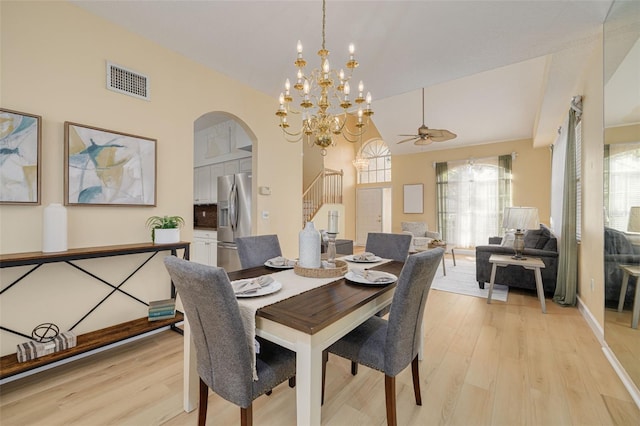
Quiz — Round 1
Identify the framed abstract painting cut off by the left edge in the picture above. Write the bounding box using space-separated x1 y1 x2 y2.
0 108 42 205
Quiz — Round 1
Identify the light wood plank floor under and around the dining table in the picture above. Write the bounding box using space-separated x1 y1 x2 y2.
0 284 640 426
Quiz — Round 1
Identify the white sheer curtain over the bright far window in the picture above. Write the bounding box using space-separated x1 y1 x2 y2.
445 157 501 247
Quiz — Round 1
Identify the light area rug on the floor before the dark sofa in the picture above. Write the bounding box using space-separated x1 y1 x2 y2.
431 252 509 302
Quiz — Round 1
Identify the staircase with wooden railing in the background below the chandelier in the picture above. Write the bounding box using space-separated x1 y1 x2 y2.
302 169 343 226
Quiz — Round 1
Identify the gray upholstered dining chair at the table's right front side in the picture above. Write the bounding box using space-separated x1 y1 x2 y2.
322 248 444 426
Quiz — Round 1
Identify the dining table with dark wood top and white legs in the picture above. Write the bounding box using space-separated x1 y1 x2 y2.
183 259 404 426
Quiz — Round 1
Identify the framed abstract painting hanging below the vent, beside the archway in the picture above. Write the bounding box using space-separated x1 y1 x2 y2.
64 121 157 207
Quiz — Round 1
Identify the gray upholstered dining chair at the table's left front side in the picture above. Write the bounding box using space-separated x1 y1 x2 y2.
164 256 296 425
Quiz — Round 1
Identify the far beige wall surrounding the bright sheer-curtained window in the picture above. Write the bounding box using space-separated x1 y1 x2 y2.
392 139 551 232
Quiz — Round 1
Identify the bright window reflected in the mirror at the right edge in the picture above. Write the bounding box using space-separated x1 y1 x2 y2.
604 142 640 232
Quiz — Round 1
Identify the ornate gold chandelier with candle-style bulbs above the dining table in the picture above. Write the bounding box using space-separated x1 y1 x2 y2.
276 0 373 155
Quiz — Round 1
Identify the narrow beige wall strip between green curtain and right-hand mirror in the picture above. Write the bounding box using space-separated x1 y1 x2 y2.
575 39 604 327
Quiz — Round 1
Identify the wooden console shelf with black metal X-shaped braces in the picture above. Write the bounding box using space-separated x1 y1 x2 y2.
0 241 189 381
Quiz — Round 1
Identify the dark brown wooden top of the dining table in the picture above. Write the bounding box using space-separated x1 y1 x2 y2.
229 261 404 334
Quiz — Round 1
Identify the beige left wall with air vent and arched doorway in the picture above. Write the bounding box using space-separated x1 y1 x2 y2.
0 2 302 354
